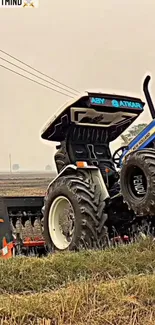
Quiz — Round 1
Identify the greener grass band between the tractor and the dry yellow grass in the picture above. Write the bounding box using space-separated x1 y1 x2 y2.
0 237 155 293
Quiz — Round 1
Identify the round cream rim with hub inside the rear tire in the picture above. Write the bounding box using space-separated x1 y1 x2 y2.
48 196 75 250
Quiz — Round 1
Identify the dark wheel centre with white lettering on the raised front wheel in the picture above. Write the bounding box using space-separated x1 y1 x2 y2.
127 166 147 200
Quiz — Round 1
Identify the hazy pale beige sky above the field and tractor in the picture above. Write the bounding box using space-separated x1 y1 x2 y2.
0 0 155 170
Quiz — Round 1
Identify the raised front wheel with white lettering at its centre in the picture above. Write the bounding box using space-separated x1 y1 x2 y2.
120 149 155 216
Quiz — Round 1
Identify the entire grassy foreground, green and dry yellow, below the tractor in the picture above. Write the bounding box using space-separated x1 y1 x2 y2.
0 240 155 325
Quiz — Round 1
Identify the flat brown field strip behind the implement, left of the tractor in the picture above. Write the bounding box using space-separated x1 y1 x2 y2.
0 172 55 196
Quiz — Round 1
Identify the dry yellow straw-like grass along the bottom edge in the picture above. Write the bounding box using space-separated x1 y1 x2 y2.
0 275 155 325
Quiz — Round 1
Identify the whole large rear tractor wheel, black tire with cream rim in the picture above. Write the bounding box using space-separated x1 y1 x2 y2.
44 173 108 250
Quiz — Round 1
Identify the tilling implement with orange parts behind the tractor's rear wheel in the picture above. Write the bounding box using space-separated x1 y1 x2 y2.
0 196 47 258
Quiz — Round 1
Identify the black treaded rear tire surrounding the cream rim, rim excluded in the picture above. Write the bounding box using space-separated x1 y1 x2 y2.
44 174 107 250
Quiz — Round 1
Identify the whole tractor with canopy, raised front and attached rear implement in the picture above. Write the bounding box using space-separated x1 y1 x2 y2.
0 76 155 257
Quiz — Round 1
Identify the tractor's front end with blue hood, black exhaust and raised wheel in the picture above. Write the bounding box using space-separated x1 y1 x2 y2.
116 76 155 216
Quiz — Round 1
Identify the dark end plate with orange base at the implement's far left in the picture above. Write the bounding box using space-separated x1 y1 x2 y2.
0 197 13 259
